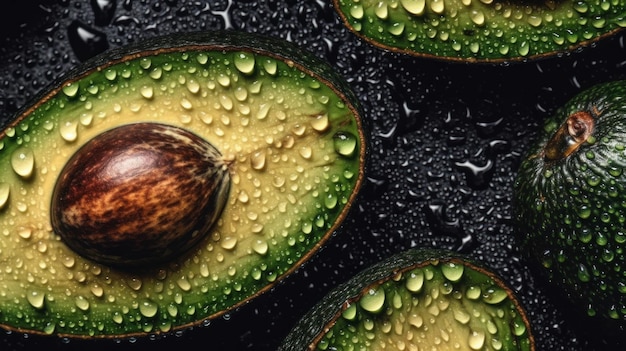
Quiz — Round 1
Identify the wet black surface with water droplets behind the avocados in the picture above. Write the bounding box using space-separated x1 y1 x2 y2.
0 0 626 350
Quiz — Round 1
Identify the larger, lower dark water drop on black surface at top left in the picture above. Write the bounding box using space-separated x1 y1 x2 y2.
67 21 109 61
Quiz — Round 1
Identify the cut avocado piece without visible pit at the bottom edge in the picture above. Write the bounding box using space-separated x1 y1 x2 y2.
279 248 535 351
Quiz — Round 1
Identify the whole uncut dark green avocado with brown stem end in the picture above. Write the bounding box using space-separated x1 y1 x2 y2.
514 81 626 325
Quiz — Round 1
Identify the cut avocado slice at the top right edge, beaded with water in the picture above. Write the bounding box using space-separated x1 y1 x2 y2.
333 0 626 63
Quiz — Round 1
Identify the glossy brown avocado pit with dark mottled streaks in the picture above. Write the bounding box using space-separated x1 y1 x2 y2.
51 122 230 267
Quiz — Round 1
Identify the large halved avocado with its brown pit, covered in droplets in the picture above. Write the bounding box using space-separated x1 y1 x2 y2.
0 31 366 339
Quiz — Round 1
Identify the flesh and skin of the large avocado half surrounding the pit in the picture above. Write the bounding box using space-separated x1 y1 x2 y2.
0 31 367 339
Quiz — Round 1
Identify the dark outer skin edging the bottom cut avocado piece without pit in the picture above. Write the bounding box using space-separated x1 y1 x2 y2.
278 248 535 351
